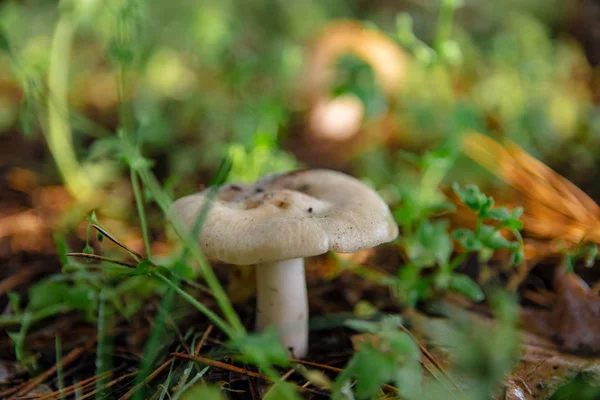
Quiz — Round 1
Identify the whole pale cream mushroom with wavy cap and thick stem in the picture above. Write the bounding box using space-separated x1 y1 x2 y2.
172 169 398 357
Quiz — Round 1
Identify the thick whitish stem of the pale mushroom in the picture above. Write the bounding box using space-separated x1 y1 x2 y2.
256 258 308 358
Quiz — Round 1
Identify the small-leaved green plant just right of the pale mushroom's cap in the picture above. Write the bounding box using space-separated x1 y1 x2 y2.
394 150 523 307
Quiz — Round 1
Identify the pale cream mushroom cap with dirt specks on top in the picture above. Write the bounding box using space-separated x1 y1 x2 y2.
171 169 398 265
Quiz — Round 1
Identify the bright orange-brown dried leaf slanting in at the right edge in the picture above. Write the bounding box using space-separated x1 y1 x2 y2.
463 133 600 259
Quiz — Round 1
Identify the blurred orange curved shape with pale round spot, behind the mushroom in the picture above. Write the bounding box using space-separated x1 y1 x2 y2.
301 20 408 167
